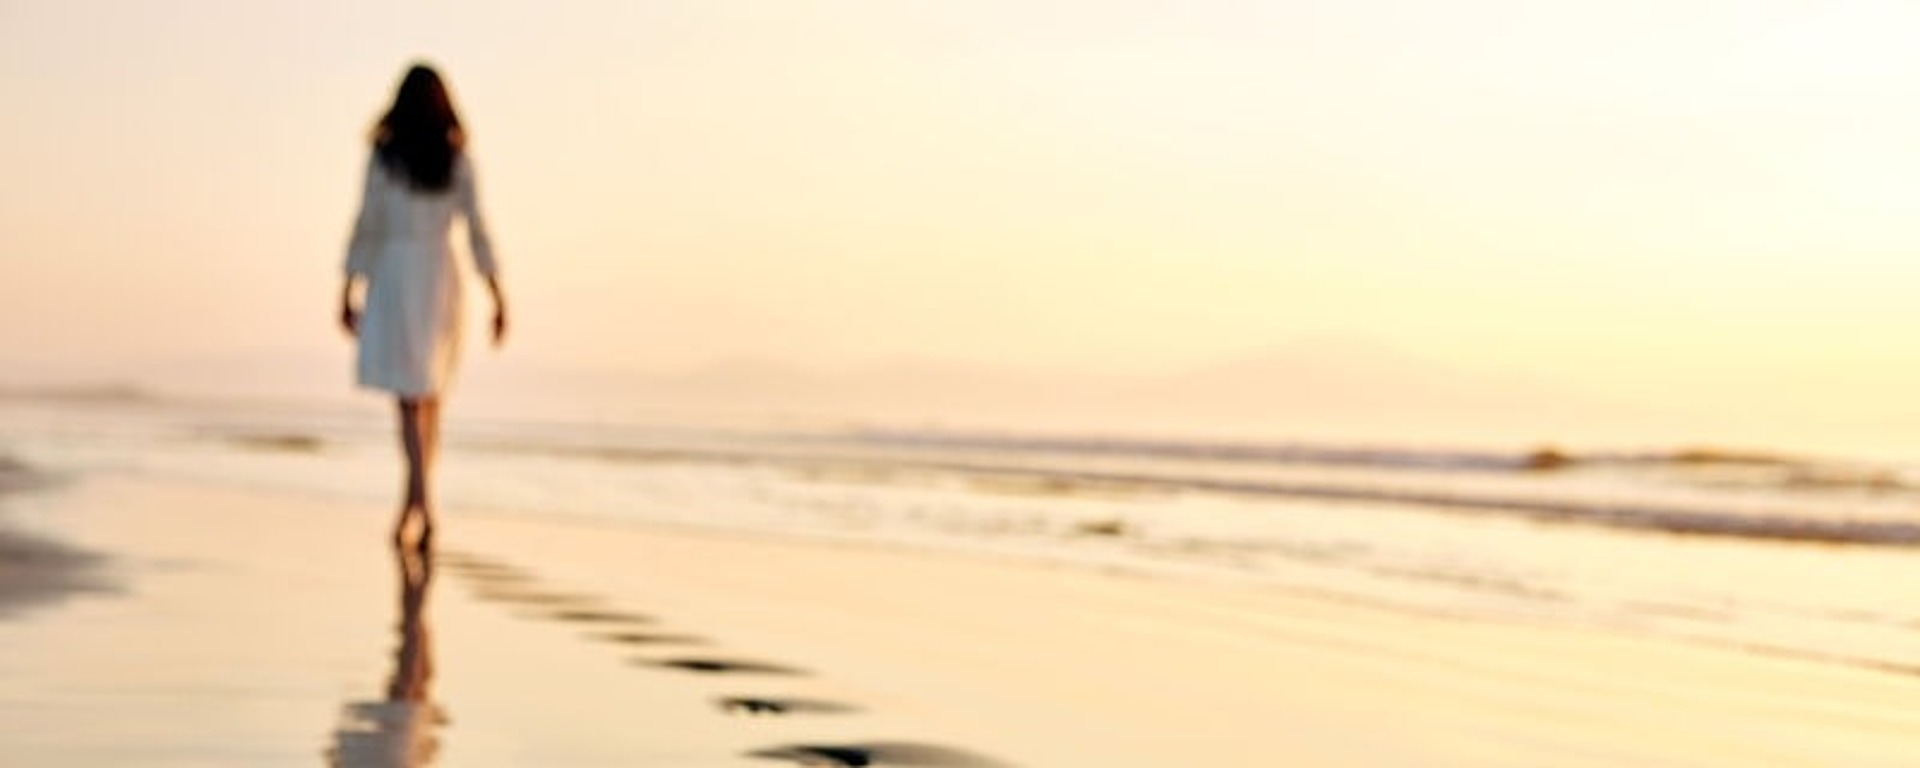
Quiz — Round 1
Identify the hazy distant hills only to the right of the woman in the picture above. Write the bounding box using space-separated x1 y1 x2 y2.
453 340 1672 440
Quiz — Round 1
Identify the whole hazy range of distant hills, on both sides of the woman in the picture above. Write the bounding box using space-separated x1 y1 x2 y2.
60 340 1672 440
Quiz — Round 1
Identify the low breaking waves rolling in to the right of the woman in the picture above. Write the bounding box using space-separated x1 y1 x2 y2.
460 432 1920 547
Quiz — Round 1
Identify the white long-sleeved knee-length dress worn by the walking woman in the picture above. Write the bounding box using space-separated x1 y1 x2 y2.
346 154 497 397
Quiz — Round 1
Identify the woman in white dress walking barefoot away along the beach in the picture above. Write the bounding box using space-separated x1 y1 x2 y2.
340 65 507 549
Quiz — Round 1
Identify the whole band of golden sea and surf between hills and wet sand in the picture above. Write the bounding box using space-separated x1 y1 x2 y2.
0 392 1920 674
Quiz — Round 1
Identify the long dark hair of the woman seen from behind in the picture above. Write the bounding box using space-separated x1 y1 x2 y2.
372 63 467 192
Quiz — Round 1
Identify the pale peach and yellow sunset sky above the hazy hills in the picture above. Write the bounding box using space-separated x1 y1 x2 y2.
0 0 1920 453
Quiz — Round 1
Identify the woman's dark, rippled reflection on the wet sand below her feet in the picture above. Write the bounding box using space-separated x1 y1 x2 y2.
326 547 445 768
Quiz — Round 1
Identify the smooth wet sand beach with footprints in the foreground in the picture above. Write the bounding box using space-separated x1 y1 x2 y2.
0 476 1920 768
